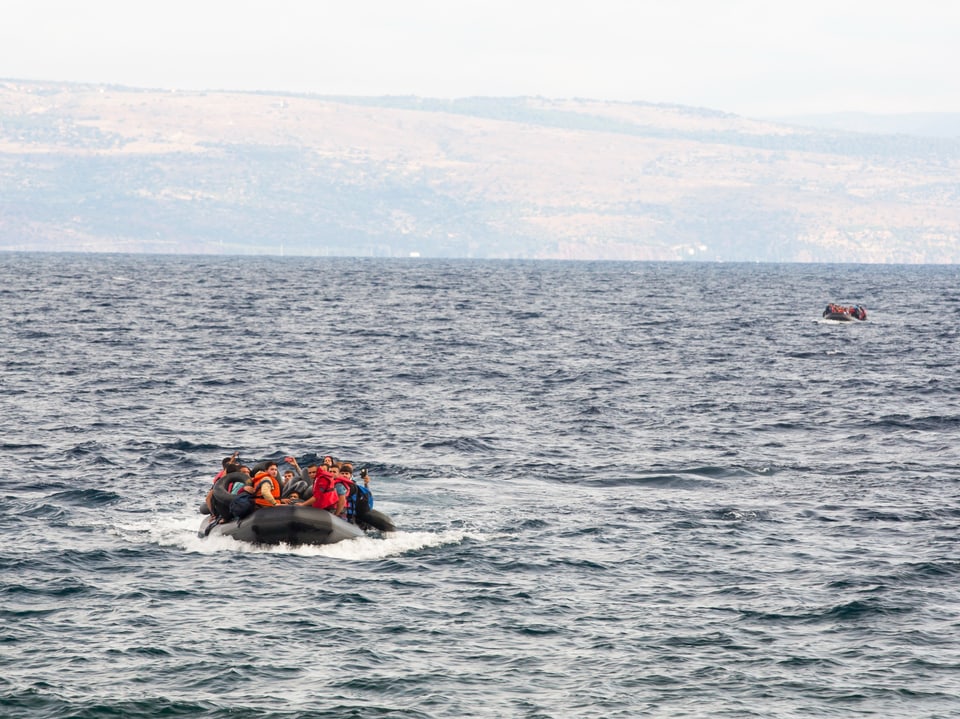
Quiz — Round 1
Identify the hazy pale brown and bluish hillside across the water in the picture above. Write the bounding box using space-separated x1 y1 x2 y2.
0 80 960 263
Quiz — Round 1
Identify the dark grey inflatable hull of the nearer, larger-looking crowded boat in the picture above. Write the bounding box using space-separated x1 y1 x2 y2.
199 504 396 546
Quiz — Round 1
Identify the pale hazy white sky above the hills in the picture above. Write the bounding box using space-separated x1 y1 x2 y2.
0 0 960 116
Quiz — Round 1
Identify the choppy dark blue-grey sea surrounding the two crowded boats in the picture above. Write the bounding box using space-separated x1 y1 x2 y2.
0 253 960 719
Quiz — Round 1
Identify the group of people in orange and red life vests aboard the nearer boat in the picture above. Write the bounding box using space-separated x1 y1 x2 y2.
206 452 373 527
